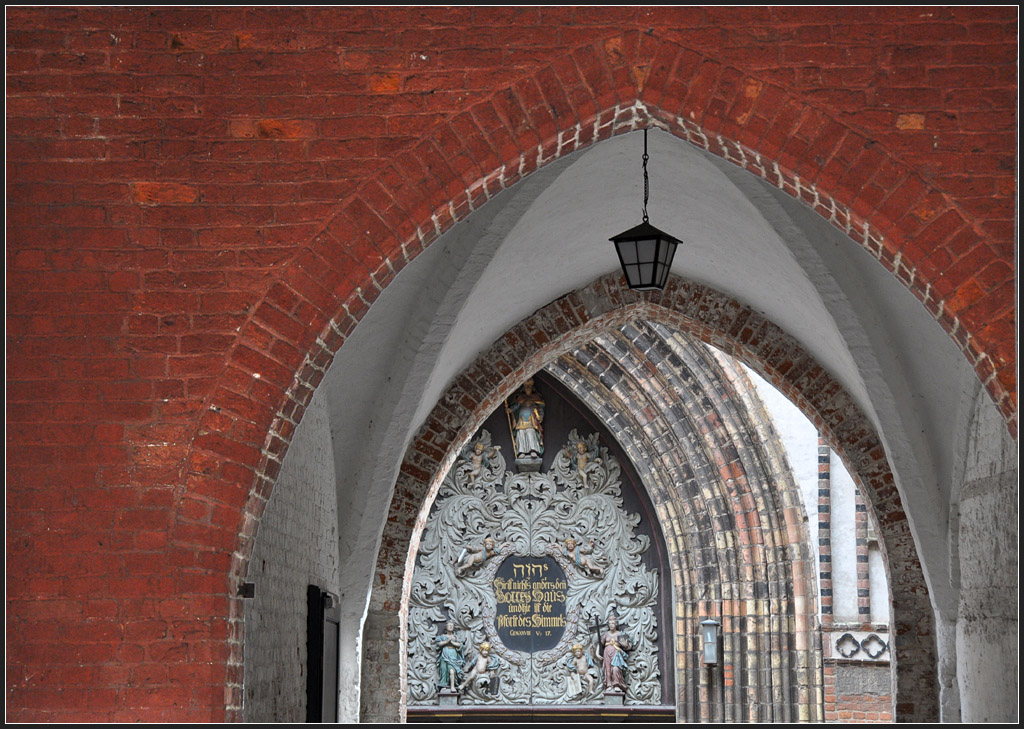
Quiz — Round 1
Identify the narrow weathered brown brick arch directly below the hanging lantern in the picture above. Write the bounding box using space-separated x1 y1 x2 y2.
371 275 938 721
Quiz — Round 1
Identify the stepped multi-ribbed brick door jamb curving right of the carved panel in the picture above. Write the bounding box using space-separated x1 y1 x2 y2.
545 320 822 723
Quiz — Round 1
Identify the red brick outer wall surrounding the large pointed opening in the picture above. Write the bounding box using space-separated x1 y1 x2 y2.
7 7 1017 721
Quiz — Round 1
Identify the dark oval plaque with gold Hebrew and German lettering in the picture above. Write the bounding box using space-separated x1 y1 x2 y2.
493 556 568 653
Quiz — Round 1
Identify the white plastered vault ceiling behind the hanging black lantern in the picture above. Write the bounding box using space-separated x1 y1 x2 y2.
315 130 980 630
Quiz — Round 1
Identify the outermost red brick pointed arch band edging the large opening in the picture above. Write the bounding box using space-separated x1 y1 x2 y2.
188 32 1003 707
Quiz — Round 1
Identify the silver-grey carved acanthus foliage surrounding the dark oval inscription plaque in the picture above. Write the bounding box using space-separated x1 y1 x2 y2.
409 430 662 704
